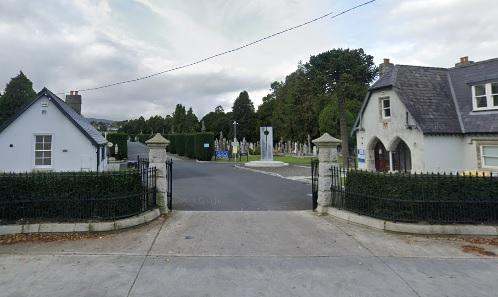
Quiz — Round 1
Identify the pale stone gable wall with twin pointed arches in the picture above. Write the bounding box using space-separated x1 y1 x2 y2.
356 90 425 171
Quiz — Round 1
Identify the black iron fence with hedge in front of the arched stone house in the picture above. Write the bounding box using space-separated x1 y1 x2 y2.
331 167 498 224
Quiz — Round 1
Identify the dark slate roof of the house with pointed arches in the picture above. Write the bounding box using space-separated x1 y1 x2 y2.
355 58 498 134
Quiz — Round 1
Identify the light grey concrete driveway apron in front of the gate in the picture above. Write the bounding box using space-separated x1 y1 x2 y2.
0 211 498 297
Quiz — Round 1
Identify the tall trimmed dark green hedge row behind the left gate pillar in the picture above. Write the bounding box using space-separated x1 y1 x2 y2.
167 132 214 161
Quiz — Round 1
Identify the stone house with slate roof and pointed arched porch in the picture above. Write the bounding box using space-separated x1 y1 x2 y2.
353 57 498 172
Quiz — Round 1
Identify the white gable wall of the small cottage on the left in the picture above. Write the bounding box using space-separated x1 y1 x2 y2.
0 97 101 172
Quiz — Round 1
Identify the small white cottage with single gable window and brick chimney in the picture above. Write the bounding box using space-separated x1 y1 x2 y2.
0 88 107 172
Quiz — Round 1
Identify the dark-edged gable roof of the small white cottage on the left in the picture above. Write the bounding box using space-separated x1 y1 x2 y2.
0 88 107 146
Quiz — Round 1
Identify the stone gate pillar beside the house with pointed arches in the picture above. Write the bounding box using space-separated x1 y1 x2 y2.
312 133 341 214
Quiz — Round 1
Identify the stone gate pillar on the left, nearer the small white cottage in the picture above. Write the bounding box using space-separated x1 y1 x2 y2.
145 133 169 213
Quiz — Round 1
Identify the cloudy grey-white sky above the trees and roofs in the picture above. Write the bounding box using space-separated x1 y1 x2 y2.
0 0 498 120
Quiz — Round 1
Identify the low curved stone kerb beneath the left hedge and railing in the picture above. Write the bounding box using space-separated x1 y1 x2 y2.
0 208 161 235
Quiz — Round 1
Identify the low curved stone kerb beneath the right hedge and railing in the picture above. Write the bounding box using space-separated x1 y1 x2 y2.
328 207 498 236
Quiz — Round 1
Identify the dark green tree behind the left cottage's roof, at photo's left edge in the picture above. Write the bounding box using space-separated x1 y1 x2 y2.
0 71 36 124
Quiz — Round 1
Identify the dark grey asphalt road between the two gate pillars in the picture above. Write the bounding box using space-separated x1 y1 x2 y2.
173 160 312 211
